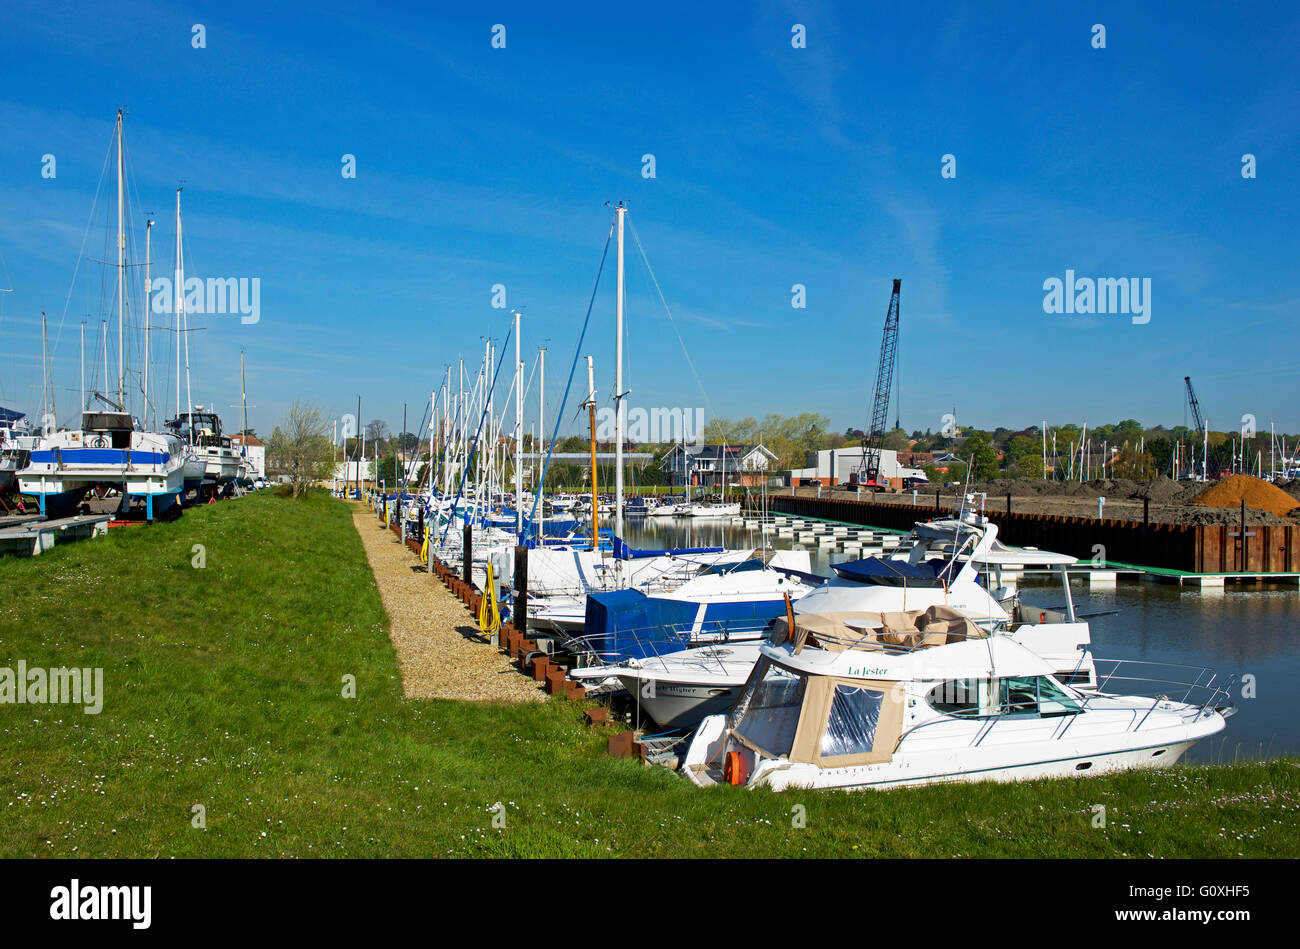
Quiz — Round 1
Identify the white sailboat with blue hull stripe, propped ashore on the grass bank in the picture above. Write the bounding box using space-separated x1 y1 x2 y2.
18 116 185 520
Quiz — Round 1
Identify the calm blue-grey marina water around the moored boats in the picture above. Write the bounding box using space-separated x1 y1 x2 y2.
627 517 1300 762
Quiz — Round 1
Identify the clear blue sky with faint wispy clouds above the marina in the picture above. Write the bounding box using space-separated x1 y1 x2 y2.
0 0 1300 432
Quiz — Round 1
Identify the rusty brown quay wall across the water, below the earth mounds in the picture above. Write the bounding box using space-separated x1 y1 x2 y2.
767 495 1300 573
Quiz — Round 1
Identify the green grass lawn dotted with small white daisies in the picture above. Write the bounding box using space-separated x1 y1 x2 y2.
0 491 1300 857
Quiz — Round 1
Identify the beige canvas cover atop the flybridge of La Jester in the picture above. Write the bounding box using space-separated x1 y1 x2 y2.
771 606 988 654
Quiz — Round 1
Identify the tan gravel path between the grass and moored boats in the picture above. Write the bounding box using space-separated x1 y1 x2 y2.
352 504 546 702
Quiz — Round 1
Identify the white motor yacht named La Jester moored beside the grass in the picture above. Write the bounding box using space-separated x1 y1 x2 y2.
683 612 1232 790
